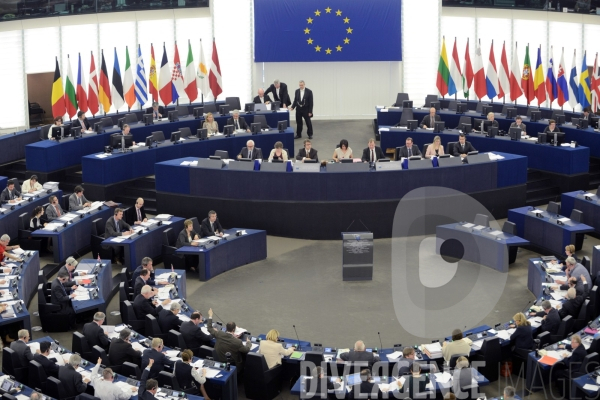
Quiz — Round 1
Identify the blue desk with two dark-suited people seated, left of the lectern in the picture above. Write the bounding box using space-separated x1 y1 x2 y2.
177 228 267 281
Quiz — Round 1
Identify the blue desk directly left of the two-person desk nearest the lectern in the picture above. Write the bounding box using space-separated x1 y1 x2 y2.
102 217 184 271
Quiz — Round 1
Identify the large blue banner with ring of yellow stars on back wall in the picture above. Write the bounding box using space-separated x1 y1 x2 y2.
254 0 402 62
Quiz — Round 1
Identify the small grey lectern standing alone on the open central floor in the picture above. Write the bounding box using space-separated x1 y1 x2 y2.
342 232 373 281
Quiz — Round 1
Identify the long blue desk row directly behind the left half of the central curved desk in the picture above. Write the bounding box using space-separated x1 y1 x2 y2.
81 128 294 185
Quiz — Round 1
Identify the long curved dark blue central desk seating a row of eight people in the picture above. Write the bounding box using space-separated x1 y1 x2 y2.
155 154 527 239
